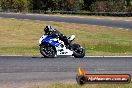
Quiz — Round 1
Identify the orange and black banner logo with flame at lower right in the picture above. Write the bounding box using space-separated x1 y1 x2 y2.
76 67 131 85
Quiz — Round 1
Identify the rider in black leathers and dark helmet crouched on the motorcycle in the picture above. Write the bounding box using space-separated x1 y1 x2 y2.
44 26 70 46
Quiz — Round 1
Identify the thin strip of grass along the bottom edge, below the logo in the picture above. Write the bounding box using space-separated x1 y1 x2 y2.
31 83 132 88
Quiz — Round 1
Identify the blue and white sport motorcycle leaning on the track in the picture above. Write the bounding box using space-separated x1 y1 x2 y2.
39 34 85 58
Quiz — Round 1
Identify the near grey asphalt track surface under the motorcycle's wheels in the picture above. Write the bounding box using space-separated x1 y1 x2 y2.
0 56 132 83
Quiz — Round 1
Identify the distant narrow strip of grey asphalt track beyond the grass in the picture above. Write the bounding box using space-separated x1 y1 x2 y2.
0 13 132 29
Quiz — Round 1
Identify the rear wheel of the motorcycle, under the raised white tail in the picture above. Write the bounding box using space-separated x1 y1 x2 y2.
72 44 85 58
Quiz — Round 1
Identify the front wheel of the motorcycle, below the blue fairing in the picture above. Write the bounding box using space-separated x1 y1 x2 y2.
40 44 56 58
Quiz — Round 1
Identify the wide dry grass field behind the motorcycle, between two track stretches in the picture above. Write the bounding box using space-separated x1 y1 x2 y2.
0 18 132 56
